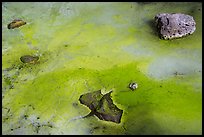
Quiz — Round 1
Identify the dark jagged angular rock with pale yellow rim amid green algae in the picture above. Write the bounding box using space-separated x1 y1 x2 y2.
79 90 123 123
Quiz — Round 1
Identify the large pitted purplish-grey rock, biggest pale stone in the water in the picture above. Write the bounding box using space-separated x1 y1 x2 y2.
155 13 196 39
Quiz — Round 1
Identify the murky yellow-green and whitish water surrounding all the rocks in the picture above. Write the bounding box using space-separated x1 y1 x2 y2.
2 2 202 134
